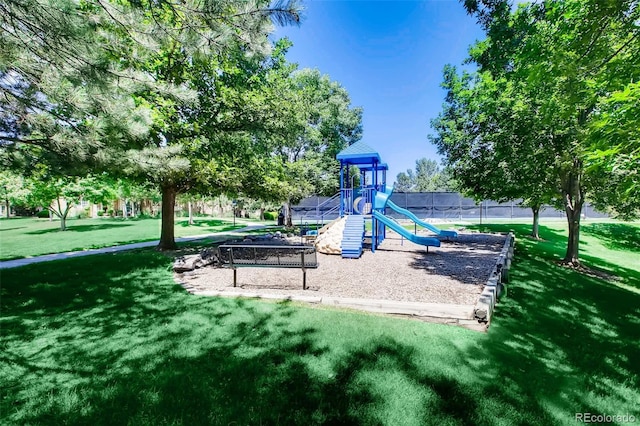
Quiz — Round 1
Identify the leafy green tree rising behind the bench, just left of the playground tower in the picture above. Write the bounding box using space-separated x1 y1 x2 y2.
273 68 362 226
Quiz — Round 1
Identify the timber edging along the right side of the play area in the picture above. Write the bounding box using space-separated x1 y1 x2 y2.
473 232 515 328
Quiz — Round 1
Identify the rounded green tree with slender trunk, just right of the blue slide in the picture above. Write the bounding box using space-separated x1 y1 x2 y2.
429 66 555 238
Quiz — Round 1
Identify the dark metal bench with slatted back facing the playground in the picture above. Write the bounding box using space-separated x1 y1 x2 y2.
218 244 318 290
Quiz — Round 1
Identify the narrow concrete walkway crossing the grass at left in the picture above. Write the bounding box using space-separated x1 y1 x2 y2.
0 225 273 269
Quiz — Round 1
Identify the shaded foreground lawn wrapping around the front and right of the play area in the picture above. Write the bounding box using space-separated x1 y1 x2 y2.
0 223 640 425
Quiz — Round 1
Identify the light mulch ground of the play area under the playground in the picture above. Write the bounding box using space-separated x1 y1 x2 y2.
176 231 508 330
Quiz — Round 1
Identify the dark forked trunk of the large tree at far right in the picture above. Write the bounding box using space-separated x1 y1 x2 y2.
562 159 584 265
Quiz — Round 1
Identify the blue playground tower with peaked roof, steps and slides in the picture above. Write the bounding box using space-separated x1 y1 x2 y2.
328 142 457 258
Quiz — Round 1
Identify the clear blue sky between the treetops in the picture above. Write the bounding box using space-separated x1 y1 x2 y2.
274 0 483 183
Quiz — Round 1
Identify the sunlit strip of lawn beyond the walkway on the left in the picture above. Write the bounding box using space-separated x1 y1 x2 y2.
0 218 264 260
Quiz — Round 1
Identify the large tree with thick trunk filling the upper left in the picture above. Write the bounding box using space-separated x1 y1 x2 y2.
0 0 300 249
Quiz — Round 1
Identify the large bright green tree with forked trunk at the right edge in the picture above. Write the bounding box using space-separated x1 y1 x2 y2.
441 0 640 264
